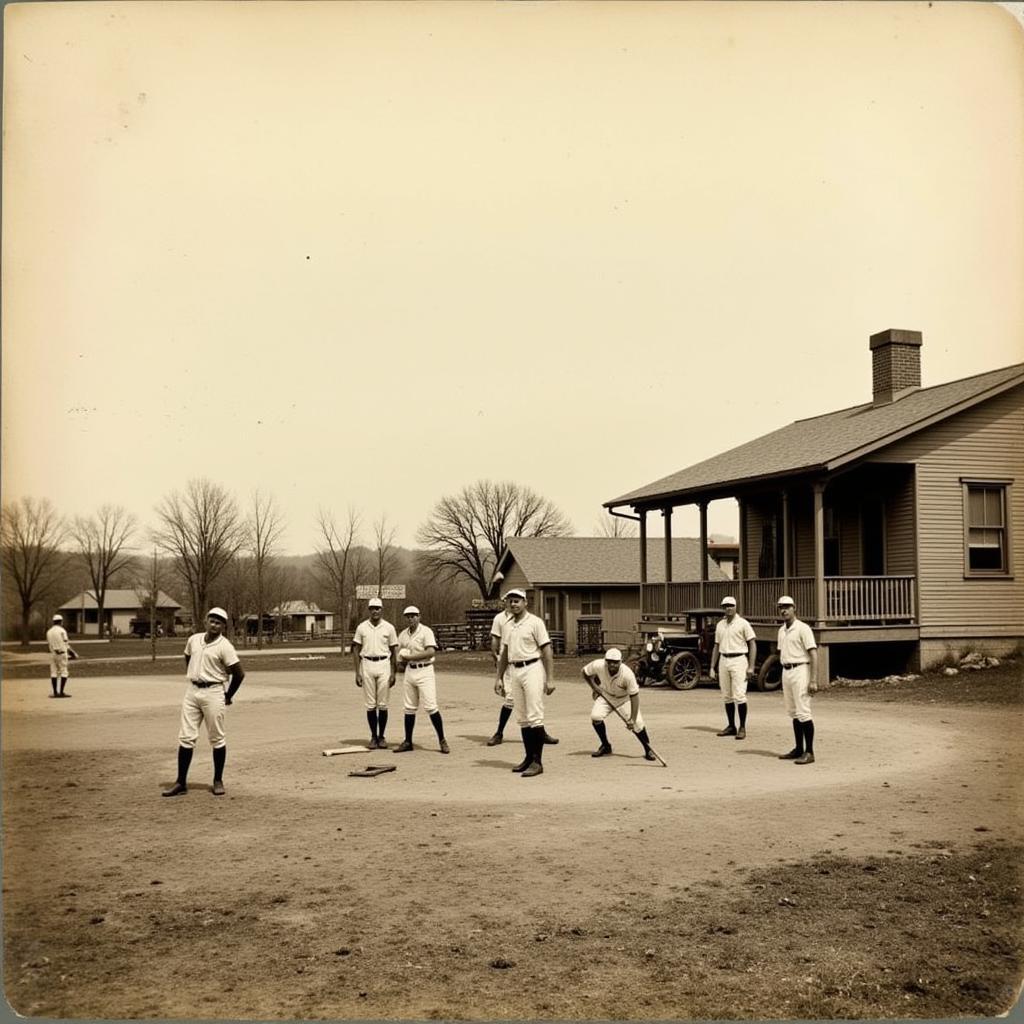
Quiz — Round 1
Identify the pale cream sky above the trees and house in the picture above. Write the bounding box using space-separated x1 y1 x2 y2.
2 0 1024 554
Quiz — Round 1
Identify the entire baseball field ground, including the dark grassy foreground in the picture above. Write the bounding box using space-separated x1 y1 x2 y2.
2 658 1024 1020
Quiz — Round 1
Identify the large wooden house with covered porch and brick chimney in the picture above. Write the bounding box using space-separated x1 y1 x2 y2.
605 330 1024 678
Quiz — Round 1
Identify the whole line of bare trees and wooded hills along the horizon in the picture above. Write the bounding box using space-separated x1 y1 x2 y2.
0 478 623 644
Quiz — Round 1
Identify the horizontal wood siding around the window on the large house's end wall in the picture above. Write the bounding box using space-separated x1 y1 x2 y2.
872 387 1024 636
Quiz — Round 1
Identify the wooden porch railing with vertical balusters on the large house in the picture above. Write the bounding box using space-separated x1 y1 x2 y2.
640 575 916 625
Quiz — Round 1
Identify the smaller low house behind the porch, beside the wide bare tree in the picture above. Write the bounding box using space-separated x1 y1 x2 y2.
497 537 726 653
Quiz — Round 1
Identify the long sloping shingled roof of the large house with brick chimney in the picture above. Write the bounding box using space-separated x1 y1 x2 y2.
604 362 1024 509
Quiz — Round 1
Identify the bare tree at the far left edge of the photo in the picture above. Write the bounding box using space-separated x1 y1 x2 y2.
0 498 67 646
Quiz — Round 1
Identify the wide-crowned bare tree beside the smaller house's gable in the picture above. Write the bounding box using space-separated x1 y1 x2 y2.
416 480 572 598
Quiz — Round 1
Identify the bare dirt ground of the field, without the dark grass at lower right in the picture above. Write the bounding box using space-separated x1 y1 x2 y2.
3 671 1024 1018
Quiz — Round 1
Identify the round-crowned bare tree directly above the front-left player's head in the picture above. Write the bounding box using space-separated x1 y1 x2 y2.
154 479 244 624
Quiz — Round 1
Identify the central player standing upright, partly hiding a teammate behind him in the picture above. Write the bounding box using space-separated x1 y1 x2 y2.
495 589 555 778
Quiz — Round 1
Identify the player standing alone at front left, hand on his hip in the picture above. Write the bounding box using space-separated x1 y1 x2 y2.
161 608 246 797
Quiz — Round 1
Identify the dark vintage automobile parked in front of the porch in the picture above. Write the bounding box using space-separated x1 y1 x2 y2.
626 608 782 690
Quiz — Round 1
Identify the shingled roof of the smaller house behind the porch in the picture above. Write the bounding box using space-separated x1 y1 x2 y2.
498 537 728 587
